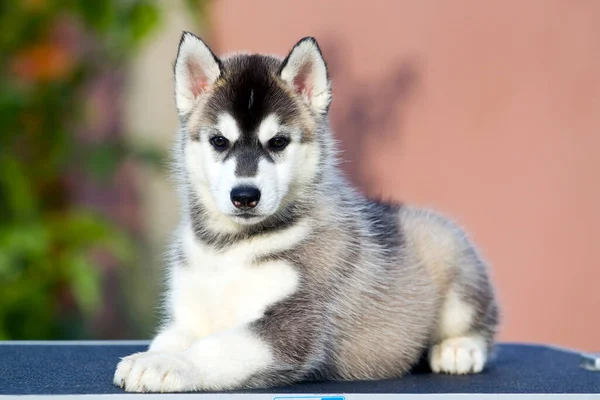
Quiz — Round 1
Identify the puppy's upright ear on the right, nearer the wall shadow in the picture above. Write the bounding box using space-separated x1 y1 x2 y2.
279 37 331 115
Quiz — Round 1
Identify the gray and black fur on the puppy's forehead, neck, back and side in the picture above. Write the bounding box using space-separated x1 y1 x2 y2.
165 35 498 387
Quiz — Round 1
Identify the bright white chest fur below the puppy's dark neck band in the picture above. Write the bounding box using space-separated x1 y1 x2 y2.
169 227 305 337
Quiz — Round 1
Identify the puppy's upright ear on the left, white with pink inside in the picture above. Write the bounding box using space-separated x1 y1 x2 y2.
174 32 223 115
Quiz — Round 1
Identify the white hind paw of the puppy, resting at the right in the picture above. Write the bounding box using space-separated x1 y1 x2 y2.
429 337 487 374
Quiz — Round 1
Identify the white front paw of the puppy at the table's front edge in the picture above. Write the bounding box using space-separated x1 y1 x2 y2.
113 352 199 392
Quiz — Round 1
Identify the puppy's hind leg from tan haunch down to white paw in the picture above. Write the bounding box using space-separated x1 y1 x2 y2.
400 207 498 374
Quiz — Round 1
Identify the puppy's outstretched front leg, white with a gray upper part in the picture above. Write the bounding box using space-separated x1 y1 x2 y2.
114 291 325 392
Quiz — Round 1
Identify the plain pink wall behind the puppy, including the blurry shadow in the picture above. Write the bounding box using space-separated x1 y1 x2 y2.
211 0 600 350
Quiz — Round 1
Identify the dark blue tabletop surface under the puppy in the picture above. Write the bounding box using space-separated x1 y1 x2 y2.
0 344 600 394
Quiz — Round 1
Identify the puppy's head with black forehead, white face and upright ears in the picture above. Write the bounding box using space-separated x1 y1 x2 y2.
175 33 331 227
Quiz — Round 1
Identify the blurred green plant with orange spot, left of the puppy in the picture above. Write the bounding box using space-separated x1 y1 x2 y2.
0 0 160 339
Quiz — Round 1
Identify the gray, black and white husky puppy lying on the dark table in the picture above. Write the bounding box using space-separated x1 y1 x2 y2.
114 32 498 392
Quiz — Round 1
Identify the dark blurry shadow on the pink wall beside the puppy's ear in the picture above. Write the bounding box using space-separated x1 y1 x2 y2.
322 39 419 194
